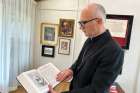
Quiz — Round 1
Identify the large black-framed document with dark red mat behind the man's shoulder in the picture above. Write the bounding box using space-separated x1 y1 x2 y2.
106 14 133 49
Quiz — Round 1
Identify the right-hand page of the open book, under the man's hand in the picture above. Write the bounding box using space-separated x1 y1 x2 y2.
38 63 60 87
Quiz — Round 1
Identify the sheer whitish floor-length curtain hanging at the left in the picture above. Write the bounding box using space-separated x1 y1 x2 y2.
0 0 36 93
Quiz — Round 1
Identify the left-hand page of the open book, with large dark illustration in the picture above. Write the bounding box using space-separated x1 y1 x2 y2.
17 70 48 93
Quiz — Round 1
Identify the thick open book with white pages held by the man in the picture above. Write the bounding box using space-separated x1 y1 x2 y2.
17 63 60 93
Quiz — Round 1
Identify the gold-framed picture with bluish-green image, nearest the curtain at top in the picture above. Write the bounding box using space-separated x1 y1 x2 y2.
40 23 58 46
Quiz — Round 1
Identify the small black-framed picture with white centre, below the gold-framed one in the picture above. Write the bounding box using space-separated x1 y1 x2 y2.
42 45 55 57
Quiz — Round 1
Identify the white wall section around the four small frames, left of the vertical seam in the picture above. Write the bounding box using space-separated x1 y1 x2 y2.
34 0 85 69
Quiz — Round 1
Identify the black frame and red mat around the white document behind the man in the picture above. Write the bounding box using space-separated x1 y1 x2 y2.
106 14 134 49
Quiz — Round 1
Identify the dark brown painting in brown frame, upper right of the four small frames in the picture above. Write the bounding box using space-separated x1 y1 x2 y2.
58 19 74 37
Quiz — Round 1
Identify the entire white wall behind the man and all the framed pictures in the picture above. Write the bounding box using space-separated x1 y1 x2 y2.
34 0 140 93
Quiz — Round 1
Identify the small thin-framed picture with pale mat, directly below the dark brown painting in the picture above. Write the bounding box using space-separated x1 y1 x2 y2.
58 38 71 55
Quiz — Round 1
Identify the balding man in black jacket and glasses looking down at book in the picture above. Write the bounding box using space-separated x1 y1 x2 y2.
49 3 124 93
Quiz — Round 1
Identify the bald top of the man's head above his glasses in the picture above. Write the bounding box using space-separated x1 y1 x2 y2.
81 3 106 22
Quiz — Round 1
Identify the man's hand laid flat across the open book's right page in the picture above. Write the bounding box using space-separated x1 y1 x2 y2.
56 69 73 81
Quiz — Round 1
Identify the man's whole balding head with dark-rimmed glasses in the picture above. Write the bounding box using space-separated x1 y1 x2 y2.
79 3 106 37
